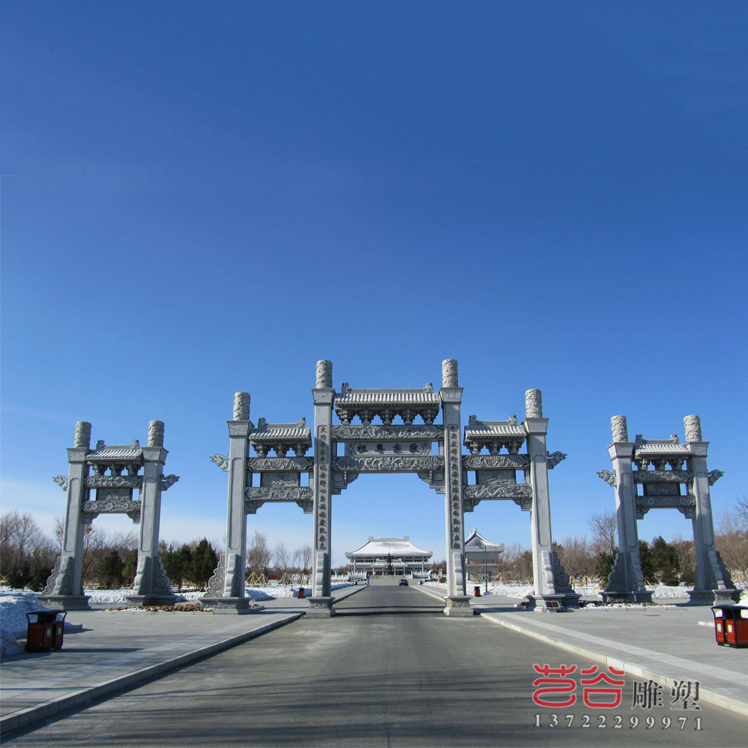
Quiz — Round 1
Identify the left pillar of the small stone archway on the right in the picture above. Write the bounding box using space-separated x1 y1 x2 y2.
599 416 652 603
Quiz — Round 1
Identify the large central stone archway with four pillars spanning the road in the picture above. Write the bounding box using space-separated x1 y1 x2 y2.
204 359 579 616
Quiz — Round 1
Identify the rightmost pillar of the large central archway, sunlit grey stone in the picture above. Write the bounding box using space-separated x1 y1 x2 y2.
523 390 580 611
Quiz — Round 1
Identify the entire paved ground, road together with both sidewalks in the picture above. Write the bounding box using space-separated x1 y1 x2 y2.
3 584 748 746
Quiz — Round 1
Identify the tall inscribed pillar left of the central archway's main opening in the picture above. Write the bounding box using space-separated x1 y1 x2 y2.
307 361 335 616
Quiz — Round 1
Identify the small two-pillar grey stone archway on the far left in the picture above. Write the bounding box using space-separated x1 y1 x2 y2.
39 421 179 610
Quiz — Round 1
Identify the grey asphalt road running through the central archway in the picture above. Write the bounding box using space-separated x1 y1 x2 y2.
3 586 748 748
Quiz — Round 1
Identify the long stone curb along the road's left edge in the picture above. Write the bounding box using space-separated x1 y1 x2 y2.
0 613 303 737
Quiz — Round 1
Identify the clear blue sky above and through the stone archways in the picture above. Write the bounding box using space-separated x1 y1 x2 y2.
0 0 748 563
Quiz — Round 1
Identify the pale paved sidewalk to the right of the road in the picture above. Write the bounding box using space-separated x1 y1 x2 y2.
416 585 748 715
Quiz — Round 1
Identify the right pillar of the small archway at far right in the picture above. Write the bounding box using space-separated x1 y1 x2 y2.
684 416 740 605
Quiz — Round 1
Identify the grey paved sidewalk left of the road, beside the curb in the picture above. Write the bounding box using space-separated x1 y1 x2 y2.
0 587 364 734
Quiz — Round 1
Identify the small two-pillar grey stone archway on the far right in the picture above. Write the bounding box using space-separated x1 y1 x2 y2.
598 416 740 605
